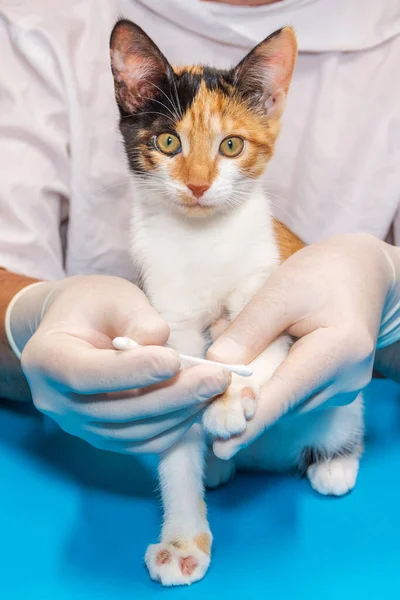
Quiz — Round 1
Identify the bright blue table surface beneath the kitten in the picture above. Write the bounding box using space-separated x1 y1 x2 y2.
0 381 400 600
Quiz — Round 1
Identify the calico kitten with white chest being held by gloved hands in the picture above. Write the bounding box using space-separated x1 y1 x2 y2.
111 20 363 585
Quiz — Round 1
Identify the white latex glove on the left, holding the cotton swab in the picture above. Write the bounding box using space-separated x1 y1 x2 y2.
10 276 230 453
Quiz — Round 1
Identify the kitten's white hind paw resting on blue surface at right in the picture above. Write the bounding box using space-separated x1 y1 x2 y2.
307 456 359 496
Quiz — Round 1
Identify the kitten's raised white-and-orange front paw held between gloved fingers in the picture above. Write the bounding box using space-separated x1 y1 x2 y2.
203 375 258 440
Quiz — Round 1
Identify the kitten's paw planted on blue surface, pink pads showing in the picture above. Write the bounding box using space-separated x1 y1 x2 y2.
144 533 211 586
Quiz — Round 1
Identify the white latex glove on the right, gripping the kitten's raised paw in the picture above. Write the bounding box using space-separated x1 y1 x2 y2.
208 234 400 459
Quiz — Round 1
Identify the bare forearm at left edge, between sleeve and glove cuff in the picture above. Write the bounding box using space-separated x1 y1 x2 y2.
0 268 36 401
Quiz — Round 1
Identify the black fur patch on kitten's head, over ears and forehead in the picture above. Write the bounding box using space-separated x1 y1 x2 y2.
110 19 288 175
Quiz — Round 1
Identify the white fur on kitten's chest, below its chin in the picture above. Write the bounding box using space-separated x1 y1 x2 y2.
132 190 279 327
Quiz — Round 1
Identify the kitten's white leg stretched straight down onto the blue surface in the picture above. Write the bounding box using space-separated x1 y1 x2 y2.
145 426 212 586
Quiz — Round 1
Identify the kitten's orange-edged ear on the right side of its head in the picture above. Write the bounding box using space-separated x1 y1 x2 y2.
234 27 297 118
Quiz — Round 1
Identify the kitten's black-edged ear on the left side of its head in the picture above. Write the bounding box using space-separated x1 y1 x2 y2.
110 19 172 113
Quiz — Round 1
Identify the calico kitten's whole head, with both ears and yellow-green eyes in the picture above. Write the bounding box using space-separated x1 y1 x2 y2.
111 21 296 217
